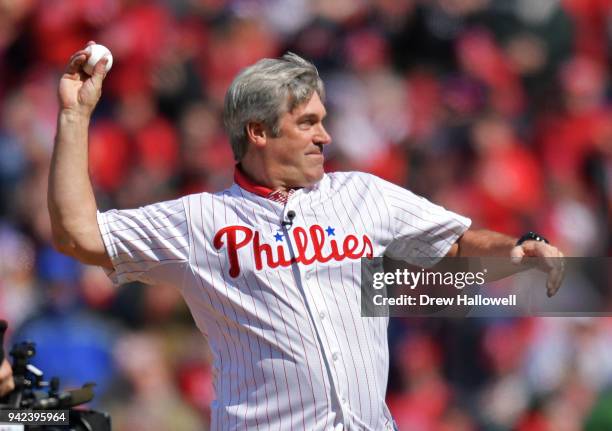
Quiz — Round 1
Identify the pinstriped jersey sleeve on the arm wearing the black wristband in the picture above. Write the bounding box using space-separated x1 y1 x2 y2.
378 179 472 266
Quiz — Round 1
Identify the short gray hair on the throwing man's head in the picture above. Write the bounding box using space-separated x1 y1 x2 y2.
223 52 325 162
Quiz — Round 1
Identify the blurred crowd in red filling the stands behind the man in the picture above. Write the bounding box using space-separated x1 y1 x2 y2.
0 0 612 431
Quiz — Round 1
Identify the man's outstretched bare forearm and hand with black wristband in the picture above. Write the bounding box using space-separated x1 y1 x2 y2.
446 229 564 297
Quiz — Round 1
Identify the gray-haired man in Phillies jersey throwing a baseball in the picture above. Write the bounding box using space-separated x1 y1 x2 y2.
49 44 562 430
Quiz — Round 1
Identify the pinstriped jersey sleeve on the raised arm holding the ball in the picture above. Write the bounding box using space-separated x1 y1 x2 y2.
98 199 189 284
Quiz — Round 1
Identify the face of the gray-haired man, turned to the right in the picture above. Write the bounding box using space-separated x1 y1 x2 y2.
266 92 331 187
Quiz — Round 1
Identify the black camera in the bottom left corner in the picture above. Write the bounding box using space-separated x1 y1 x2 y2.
0 320 111 431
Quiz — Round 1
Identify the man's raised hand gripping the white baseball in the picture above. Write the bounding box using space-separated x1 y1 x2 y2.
58 41 107 117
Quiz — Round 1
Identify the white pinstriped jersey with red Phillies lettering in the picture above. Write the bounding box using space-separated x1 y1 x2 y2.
98 172 470 431
